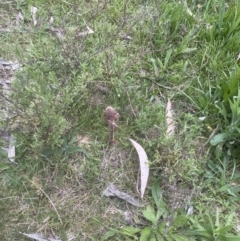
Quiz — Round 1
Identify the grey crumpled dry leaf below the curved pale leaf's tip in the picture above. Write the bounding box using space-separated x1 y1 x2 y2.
103 184 143 207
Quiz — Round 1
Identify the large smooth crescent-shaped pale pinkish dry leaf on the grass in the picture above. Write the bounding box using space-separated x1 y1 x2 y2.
129 139 149 198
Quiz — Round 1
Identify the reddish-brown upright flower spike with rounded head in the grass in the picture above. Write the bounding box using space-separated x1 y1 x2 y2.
104 106 119 144
